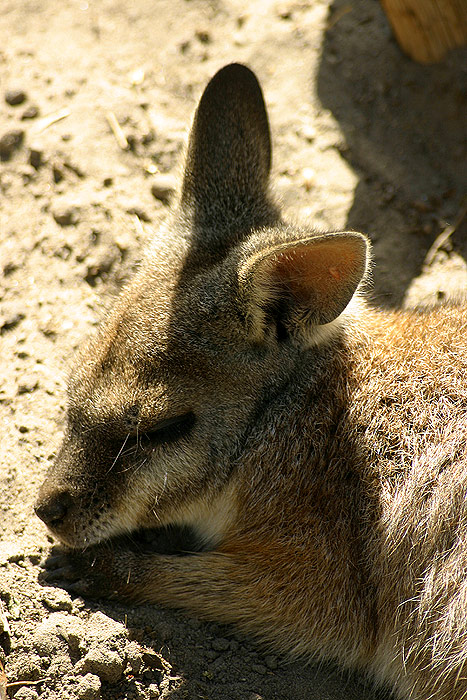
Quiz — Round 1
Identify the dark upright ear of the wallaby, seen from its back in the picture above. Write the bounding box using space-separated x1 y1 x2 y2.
180 63 271 228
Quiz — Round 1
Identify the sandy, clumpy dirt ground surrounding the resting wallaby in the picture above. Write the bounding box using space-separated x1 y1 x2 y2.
0 0 467 700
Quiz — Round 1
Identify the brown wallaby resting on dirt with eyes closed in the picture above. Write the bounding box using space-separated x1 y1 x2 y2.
36 64 467 700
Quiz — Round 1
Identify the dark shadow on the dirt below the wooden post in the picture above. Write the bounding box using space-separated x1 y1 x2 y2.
317 0 467 306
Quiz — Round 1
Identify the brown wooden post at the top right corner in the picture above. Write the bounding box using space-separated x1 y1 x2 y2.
381 0 467 63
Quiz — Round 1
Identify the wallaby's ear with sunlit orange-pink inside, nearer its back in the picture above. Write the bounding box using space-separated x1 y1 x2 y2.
239 232 369 343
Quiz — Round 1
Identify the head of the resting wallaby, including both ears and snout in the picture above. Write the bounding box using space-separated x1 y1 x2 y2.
36 64 368 547
